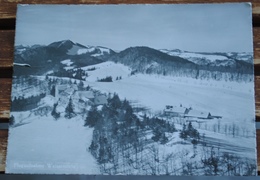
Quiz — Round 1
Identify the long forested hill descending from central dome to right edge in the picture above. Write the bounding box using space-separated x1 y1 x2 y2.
109 47 253 81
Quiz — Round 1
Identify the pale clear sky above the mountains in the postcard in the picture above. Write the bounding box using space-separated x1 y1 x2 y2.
15 3 253 52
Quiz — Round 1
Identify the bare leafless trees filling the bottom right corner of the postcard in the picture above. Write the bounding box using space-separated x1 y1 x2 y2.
178 146 256 176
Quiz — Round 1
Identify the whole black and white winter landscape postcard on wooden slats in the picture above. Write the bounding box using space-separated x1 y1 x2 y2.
6 3 257 176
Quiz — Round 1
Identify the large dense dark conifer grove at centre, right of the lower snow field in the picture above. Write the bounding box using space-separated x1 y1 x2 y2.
85 94 141 165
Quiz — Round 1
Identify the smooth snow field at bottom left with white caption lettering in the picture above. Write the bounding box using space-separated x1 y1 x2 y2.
6 116 99 174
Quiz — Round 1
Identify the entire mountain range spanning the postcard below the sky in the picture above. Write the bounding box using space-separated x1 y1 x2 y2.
15 40 253 82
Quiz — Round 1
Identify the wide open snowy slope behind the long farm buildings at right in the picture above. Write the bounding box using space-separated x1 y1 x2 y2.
89 71 254 122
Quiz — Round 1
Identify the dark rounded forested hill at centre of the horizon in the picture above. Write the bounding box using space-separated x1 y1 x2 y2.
109 47 197 75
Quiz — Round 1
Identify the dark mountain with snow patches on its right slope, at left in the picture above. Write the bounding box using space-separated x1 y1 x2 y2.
14 40 115 75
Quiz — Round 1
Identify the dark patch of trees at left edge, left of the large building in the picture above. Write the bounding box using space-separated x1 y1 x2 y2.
11 93 46 111
